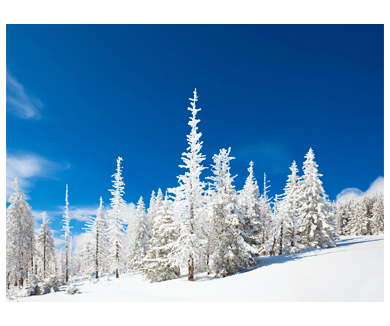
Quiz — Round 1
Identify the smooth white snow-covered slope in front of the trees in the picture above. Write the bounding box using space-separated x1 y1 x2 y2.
13 235 384 302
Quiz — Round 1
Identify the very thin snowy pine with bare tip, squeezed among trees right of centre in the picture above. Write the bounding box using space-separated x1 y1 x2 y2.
259 173 272 246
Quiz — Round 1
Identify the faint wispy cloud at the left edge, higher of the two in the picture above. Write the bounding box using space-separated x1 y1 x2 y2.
7 71 43 119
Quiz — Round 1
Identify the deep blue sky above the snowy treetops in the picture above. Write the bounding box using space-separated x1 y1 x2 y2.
6 25 384 246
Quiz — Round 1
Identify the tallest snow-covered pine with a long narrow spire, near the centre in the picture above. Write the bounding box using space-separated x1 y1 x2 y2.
168 89 207 281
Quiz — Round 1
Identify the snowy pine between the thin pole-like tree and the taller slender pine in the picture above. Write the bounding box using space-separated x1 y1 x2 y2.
86 197 110 278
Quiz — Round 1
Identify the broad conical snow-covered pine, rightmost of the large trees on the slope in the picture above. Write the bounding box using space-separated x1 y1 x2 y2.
297 148 336 248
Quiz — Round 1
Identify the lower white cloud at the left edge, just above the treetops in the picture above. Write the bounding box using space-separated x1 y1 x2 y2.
6 152 70 199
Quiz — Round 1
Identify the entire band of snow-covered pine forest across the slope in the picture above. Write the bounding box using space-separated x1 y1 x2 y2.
6 90 384 296
